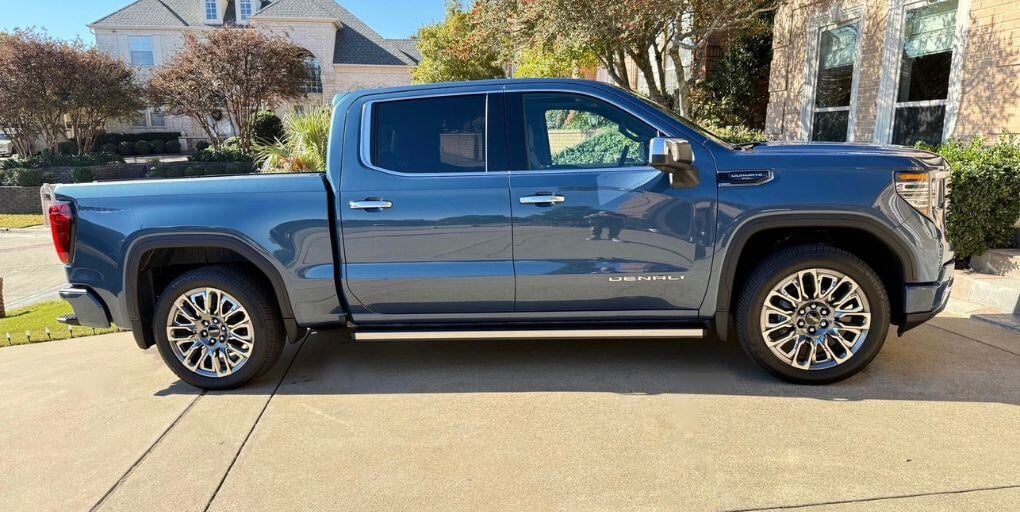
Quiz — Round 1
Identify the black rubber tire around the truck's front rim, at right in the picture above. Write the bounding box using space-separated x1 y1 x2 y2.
735 245 889 385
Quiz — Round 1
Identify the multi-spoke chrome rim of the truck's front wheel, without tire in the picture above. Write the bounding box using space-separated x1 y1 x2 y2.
760 268 871 370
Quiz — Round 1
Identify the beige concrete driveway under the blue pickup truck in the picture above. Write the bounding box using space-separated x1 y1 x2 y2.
0 317 1020 511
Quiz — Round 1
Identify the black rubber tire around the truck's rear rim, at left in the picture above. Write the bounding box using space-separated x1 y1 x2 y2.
153 265 286 390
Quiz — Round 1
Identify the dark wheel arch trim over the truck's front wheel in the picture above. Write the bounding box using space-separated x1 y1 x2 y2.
715 214 917 340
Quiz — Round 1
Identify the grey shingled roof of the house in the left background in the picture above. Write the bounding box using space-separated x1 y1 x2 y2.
90 0 421 65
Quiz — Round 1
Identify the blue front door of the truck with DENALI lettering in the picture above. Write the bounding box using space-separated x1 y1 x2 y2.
506 92 715 312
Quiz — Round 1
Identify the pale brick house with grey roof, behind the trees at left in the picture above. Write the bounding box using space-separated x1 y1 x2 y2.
89 0 420 140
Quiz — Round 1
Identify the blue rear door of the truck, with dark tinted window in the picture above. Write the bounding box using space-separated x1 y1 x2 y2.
339 92 514 321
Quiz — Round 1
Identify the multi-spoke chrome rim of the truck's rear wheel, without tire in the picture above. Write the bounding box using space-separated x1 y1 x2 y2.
166 288 255 377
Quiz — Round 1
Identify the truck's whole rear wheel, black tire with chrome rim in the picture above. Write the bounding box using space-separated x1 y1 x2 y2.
153 266 285 390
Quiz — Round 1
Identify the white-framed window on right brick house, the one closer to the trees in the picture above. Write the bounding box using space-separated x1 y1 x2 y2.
811 24 858 142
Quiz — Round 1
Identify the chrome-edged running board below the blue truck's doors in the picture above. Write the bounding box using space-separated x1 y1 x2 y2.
354 328 705 342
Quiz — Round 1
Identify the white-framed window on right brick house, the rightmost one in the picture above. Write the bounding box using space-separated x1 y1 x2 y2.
890 0 958 146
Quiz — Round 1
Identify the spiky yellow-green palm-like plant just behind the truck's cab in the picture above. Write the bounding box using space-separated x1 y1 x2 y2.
255 106 333 172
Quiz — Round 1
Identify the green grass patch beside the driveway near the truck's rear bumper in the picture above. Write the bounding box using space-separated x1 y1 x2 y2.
0 301 116 347
